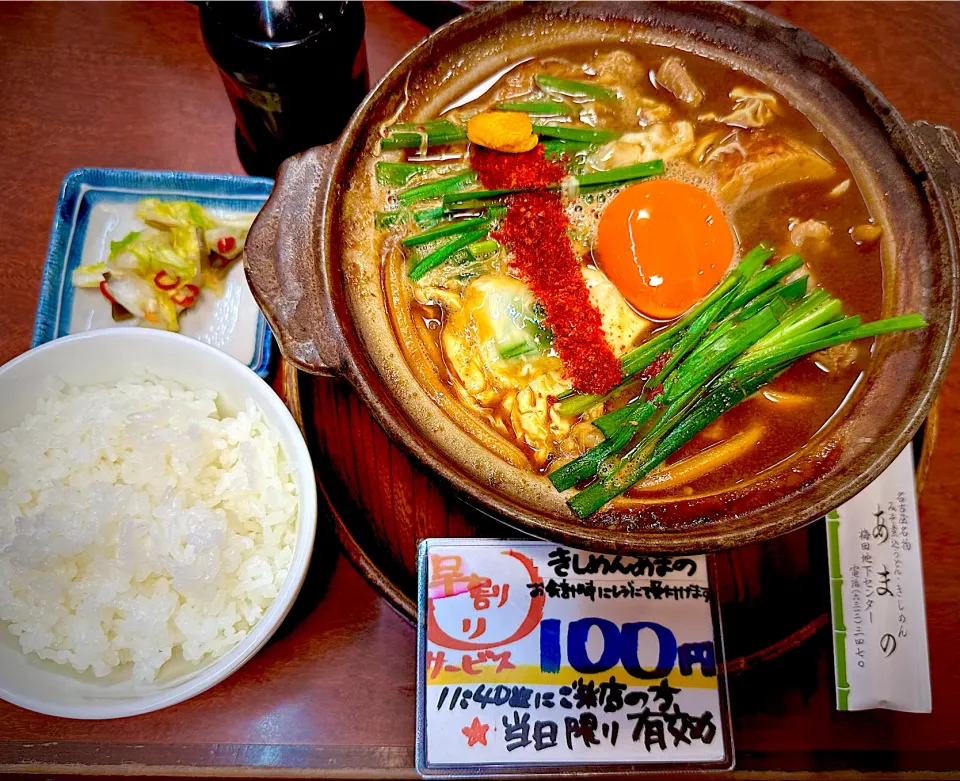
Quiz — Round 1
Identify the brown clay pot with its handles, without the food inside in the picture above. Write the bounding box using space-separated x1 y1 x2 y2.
245 3 960 553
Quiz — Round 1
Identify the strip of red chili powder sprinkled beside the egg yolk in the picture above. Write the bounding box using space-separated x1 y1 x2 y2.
471 145 621 394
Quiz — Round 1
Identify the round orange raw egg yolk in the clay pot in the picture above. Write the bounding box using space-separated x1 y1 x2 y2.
597 179 733 320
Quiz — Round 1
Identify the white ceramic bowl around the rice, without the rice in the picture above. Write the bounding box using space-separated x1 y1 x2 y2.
0 328 317 719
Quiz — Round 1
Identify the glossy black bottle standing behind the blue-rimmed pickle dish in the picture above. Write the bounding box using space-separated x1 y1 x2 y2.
197 0 369 177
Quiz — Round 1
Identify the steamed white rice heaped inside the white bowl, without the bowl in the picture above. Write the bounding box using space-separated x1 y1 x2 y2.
0 378 297 681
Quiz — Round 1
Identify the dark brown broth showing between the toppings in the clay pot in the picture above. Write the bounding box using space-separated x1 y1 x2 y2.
382 39 882 500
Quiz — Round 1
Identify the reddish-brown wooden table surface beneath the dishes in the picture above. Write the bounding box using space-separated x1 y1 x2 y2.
0 2 960 778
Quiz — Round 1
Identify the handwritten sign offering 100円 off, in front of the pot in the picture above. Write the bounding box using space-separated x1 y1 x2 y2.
417 540 732 775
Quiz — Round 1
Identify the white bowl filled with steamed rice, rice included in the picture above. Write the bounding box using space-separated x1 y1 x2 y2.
0 328 317 719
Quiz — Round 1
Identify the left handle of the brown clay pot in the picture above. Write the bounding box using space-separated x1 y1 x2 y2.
243 142 345 377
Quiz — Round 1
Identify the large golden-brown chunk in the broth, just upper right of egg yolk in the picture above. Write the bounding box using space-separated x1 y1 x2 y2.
707 131 834 205
